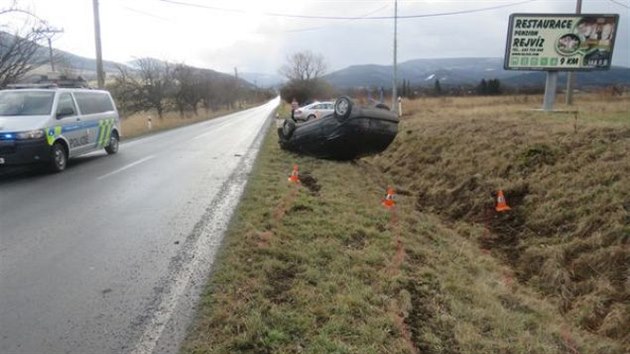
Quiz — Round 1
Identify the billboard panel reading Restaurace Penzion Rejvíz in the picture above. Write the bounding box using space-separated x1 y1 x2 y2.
503 14 619 71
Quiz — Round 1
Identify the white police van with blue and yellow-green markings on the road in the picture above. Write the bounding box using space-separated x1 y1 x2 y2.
0 84 121 172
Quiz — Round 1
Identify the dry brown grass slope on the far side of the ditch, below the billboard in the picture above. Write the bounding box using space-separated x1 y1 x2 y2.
369 91 630 349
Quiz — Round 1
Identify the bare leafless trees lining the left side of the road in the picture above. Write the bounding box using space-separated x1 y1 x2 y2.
0 1 275 117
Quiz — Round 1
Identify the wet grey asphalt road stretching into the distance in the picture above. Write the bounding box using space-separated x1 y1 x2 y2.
0 99 279 354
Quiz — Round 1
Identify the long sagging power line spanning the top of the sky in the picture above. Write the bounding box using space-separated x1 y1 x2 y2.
157 0 537 20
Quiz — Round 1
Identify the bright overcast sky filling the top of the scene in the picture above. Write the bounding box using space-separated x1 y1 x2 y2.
0 0 630 74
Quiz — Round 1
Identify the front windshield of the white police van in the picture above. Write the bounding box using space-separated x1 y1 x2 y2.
0 91 55 116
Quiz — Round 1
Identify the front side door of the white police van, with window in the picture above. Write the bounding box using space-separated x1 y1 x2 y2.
55 92 89 156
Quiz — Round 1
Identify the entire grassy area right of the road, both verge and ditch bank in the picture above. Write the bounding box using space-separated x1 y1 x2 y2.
182 95 630 353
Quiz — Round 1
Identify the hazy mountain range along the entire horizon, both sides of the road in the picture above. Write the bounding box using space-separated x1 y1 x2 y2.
0 32 630 89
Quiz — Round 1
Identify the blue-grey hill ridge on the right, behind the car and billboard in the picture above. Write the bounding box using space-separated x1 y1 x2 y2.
324 58 630 88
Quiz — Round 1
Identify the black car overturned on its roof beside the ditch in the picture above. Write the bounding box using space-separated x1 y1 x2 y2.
278 97 398 160
